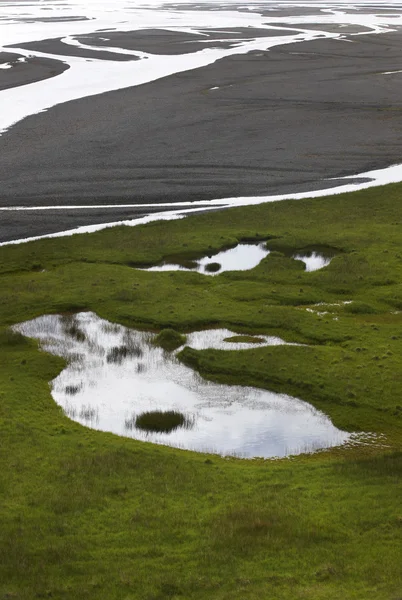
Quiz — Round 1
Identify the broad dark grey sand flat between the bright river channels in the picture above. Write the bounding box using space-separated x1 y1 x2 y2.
0 33 402 239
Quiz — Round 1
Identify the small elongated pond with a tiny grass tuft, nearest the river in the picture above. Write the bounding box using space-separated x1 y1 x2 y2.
146 242 270 275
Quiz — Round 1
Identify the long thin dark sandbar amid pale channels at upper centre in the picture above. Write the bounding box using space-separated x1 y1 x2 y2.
76 27 294 55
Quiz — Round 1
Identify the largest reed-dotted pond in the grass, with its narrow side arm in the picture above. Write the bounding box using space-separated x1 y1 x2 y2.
15 312 350 458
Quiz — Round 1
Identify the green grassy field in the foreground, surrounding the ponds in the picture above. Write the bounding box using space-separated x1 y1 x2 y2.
0 185 402 600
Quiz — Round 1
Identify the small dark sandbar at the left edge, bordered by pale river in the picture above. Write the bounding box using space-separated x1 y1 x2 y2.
0 52 70 90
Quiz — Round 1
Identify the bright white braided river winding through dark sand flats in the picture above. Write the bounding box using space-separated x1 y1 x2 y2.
0 0 402 244
